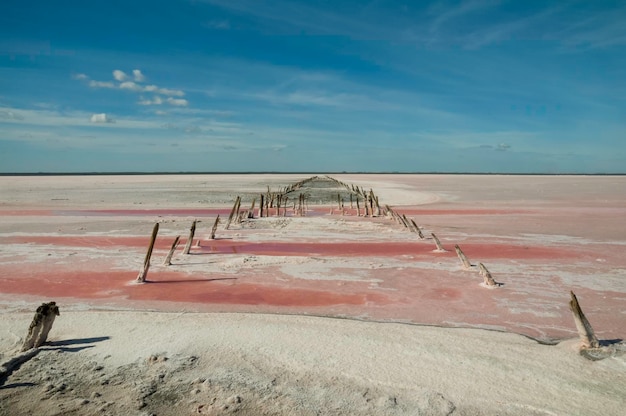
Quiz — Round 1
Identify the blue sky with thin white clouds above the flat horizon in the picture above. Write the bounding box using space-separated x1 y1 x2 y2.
0 0 626 173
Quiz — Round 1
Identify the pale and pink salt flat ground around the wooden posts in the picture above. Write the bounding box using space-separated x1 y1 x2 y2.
0 175 626 415
